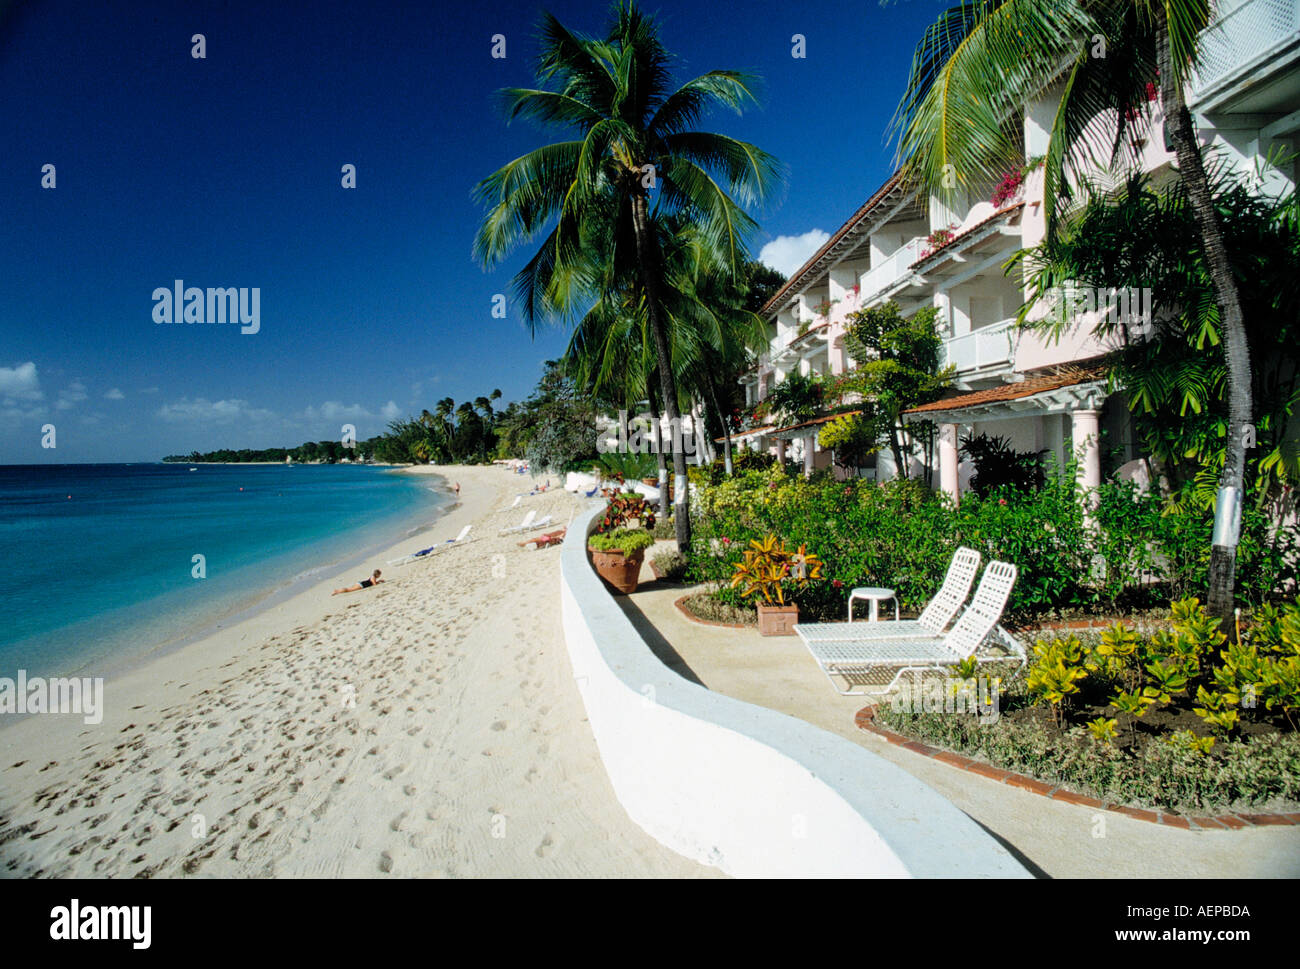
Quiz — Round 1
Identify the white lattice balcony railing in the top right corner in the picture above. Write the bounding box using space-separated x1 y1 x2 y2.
1190 0 1300 103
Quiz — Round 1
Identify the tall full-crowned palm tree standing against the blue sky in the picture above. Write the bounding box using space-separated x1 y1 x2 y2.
475 3 779 548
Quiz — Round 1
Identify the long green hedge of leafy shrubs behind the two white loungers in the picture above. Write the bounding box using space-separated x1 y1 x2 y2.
690 462 1300 618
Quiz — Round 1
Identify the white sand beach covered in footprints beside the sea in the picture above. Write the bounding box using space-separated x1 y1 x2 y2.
0 467 718 877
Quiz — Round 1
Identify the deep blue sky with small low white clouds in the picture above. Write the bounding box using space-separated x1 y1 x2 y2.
0 0 948 464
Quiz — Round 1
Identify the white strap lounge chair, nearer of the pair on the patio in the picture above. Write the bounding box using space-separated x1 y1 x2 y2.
794 562 1026 696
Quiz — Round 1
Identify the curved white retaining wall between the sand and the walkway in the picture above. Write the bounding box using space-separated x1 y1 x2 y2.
560 503 1030 878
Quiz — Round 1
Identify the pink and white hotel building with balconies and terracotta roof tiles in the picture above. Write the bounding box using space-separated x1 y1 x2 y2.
735 0 1300 497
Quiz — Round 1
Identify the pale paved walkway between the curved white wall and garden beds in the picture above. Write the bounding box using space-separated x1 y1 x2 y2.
616 543 1300 878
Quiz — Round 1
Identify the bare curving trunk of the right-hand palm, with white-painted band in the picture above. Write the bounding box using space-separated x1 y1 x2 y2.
1156 15 1253 630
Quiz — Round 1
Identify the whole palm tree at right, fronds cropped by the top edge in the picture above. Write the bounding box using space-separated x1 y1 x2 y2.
894 0 1253 617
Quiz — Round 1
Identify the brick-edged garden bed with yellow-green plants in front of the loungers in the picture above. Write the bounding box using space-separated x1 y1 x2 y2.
876 600 1300 814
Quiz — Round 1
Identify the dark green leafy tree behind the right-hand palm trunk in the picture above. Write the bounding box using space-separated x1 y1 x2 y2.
1021 159 1300 507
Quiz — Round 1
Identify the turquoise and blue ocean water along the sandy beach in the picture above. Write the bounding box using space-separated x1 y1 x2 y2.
0 464 454 676
